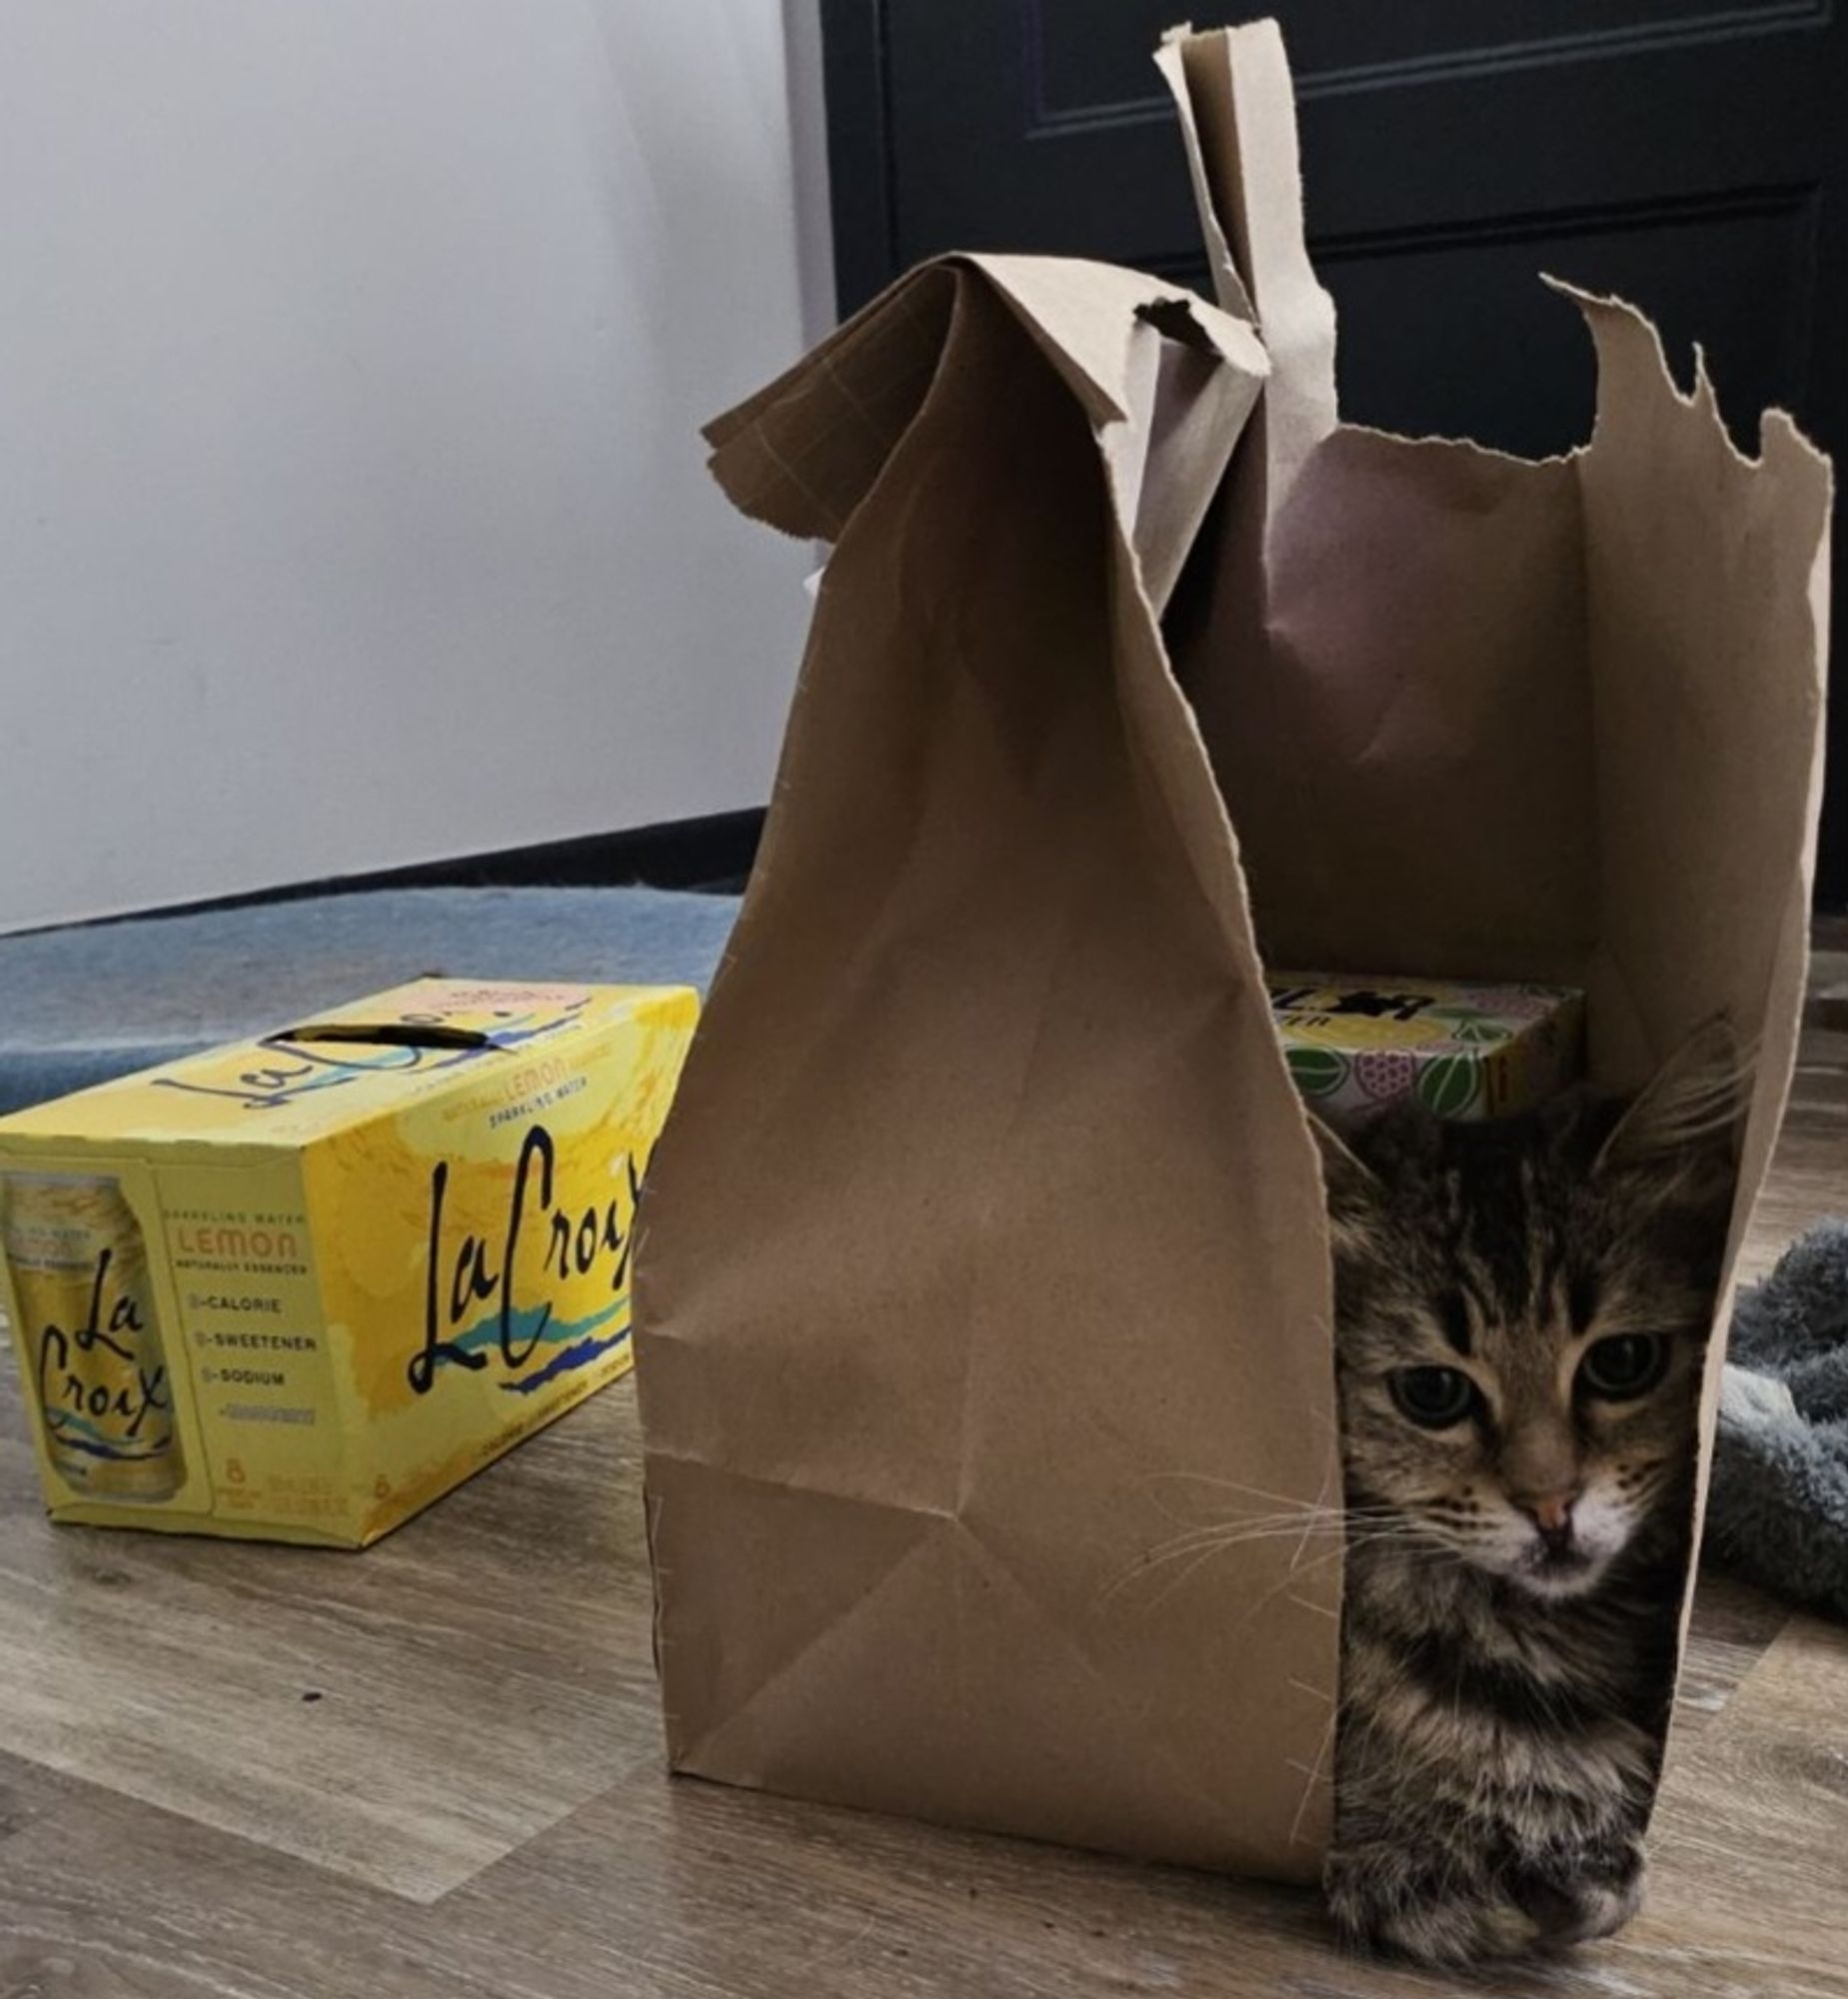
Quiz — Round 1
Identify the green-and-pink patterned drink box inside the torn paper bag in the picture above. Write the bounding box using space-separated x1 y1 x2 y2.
1266 972 1584 1125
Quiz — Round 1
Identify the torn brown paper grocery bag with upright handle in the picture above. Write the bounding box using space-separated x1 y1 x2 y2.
638 22 1830 1879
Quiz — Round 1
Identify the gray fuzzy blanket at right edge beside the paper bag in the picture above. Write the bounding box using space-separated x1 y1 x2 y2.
1706 1221 1848 1617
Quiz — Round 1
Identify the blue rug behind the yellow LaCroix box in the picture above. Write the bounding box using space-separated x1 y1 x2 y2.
0 888 738 1111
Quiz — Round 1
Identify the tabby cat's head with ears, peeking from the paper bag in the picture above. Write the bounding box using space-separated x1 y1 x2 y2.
1324 1031 1736 1597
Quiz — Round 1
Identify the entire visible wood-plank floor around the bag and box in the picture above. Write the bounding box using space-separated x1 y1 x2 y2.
0 960 1848 1999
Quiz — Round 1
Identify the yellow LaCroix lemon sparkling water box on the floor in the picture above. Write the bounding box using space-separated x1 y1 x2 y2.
0 980 698 1547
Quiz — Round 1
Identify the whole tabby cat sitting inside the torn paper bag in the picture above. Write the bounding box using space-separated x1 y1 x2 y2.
1322 1027 1742 1963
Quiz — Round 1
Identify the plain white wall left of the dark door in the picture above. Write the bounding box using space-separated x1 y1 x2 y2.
0 0 814 928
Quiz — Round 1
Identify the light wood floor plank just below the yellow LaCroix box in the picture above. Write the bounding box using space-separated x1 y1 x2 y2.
0 1381 658 1899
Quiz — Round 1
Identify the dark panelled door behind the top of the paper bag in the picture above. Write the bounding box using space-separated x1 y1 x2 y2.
822 0 1848 906
